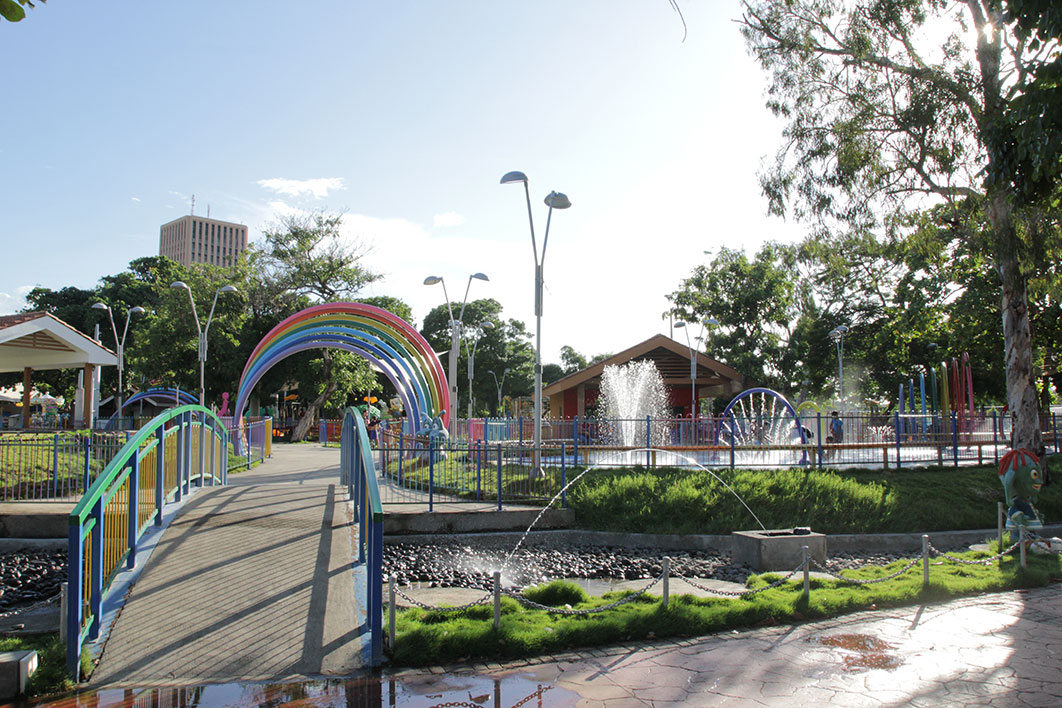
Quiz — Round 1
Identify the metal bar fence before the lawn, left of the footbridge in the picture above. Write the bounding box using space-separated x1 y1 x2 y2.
0 432 130 501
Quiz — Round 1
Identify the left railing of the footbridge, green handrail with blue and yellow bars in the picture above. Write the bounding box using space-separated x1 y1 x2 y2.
63 405 228 676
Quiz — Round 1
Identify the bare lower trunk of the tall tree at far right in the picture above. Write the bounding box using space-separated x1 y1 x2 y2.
988 190 1043 455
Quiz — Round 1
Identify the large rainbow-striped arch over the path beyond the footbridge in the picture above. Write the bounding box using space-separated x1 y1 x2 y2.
233 303 450 443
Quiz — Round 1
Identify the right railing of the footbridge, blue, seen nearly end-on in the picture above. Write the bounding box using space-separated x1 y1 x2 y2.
340 408 383 666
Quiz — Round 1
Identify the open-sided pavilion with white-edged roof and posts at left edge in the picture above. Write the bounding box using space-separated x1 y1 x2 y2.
0 312 118 428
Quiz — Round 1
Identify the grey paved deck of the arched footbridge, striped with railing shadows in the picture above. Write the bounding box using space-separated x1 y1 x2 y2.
91 445 367 686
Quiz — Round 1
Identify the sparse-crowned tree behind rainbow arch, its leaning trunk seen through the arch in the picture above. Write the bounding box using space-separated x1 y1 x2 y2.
254 211 382 441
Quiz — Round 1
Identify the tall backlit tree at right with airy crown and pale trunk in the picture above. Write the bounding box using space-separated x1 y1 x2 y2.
742 0 1058 450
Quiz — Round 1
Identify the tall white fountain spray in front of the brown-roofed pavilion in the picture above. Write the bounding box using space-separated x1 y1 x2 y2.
601 360 668 447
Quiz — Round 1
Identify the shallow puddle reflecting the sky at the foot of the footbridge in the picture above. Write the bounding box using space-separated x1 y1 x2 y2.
0 674 579 708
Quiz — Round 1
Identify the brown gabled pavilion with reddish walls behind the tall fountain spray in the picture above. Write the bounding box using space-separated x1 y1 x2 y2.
543 334 749 418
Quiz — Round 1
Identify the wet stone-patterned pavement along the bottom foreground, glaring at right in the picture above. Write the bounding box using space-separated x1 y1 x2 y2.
8 584 1062 708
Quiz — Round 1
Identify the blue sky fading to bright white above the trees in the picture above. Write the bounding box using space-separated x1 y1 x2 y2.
0 0 803 363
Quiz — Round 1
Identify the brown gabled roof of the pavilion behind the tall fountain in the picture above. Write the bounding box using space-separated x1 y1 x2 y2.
543 334 747 418
